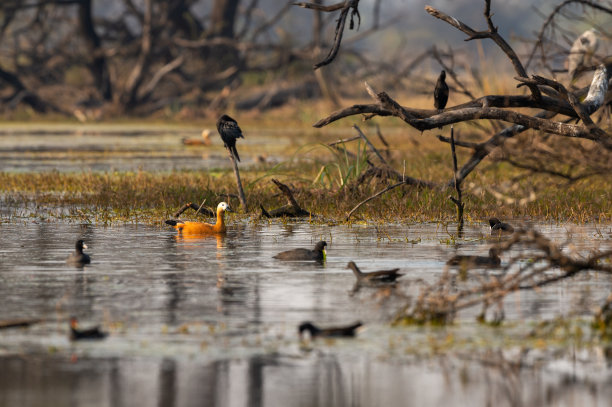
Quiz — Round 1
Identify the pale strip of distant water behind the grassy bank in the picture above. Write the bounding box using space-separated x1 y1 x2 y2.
0 124 304 172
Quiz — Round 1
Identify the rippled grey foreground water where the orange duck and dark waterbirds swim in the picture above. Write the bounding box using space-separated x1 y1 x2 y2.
0 218 612 406
